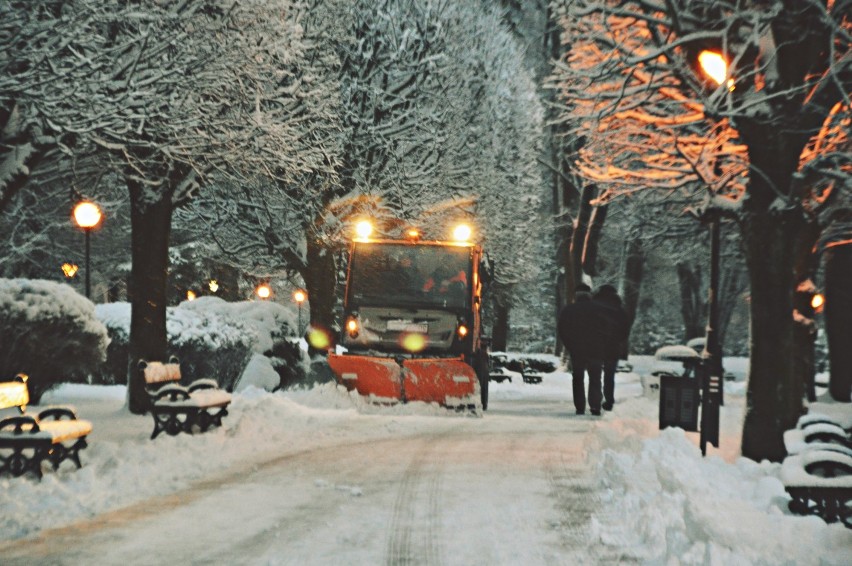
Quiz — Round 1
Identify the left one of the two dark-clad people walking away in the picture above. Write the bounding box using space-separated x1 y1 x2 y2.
557 283 608 415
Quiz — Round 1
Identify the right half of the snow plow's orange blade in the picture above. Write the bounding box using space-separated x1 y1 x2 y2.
402 358 477 406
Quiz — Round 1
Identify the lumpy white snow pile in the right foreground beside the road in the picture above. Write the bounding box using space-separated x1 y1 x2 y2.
595 429 850 565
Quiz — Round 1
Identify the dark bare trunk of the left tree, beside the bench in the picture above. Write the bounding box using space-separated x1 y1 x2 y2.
127 179 172 414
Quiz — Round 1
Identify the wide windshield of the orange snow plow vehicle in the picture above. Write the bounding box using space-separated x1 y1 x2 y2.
348 243 471 308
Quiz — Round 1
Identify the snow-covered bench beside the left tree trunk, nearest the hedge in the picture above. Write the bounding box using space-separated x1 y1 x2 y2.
139 358 231 439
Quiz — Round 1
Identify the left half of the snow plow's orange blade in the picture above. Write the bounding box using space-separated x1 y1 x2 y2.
328 354 402 402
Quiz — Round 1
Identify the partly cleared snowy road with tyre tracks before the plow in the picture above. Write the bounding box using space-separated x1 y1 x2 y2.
0 399 618 565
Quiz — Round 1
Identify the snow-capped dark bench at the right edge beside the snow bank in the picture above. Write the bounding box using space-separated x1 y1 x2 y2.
781 415 852 528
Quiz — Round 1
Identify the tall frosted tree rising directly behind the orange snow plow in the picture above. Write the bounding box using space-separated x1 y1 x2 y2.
178 0 540 346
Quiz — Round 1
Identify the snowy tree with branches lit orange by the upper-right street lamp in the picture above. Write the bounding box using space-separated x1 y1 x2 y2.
556 0 852 460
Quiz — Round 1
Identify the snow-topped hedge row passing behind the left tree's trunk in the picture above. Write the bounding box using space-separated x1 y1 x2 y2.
94 297 307 390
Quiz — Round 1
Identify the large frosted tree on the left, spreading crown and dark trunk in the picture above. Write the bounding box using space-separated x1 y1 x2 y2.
0 0 334 411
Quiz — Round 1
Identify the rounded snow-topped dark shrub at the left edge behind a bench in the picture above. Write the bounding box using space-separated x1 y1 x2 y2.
0 279 109 403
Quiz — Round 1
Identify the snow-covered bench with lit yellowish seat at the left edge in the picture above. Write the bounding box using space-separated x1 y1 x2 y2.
0 374 92 478
